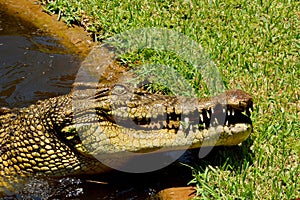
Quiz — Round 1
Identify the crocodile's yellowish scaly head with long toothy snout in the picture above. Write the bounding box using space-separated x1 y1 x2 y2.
74 85 253 156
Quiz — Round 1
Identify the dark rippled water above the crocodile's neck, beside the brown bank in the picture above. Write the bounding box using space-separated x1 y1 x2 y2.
0 7 80 107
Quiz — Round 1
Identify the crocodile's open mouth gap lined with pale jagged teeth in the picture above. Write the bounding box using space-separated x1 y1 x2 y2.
101 102 253 132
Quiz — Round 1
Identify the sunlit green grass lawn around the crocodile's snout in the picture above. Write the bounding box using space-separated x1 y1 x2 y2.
43 0 300 199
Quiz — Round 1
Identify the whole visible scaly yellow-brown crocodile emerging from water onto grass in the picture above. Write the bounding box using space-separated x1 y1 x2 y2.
0 84 253 193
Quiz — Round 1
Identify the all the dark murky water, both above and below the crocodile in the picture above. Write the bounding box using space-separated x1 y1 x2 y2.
0 4 197 200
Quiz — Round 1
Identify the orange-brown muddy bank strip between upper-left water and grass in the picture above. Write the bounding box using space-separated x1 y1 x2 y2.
0 0 95 57
